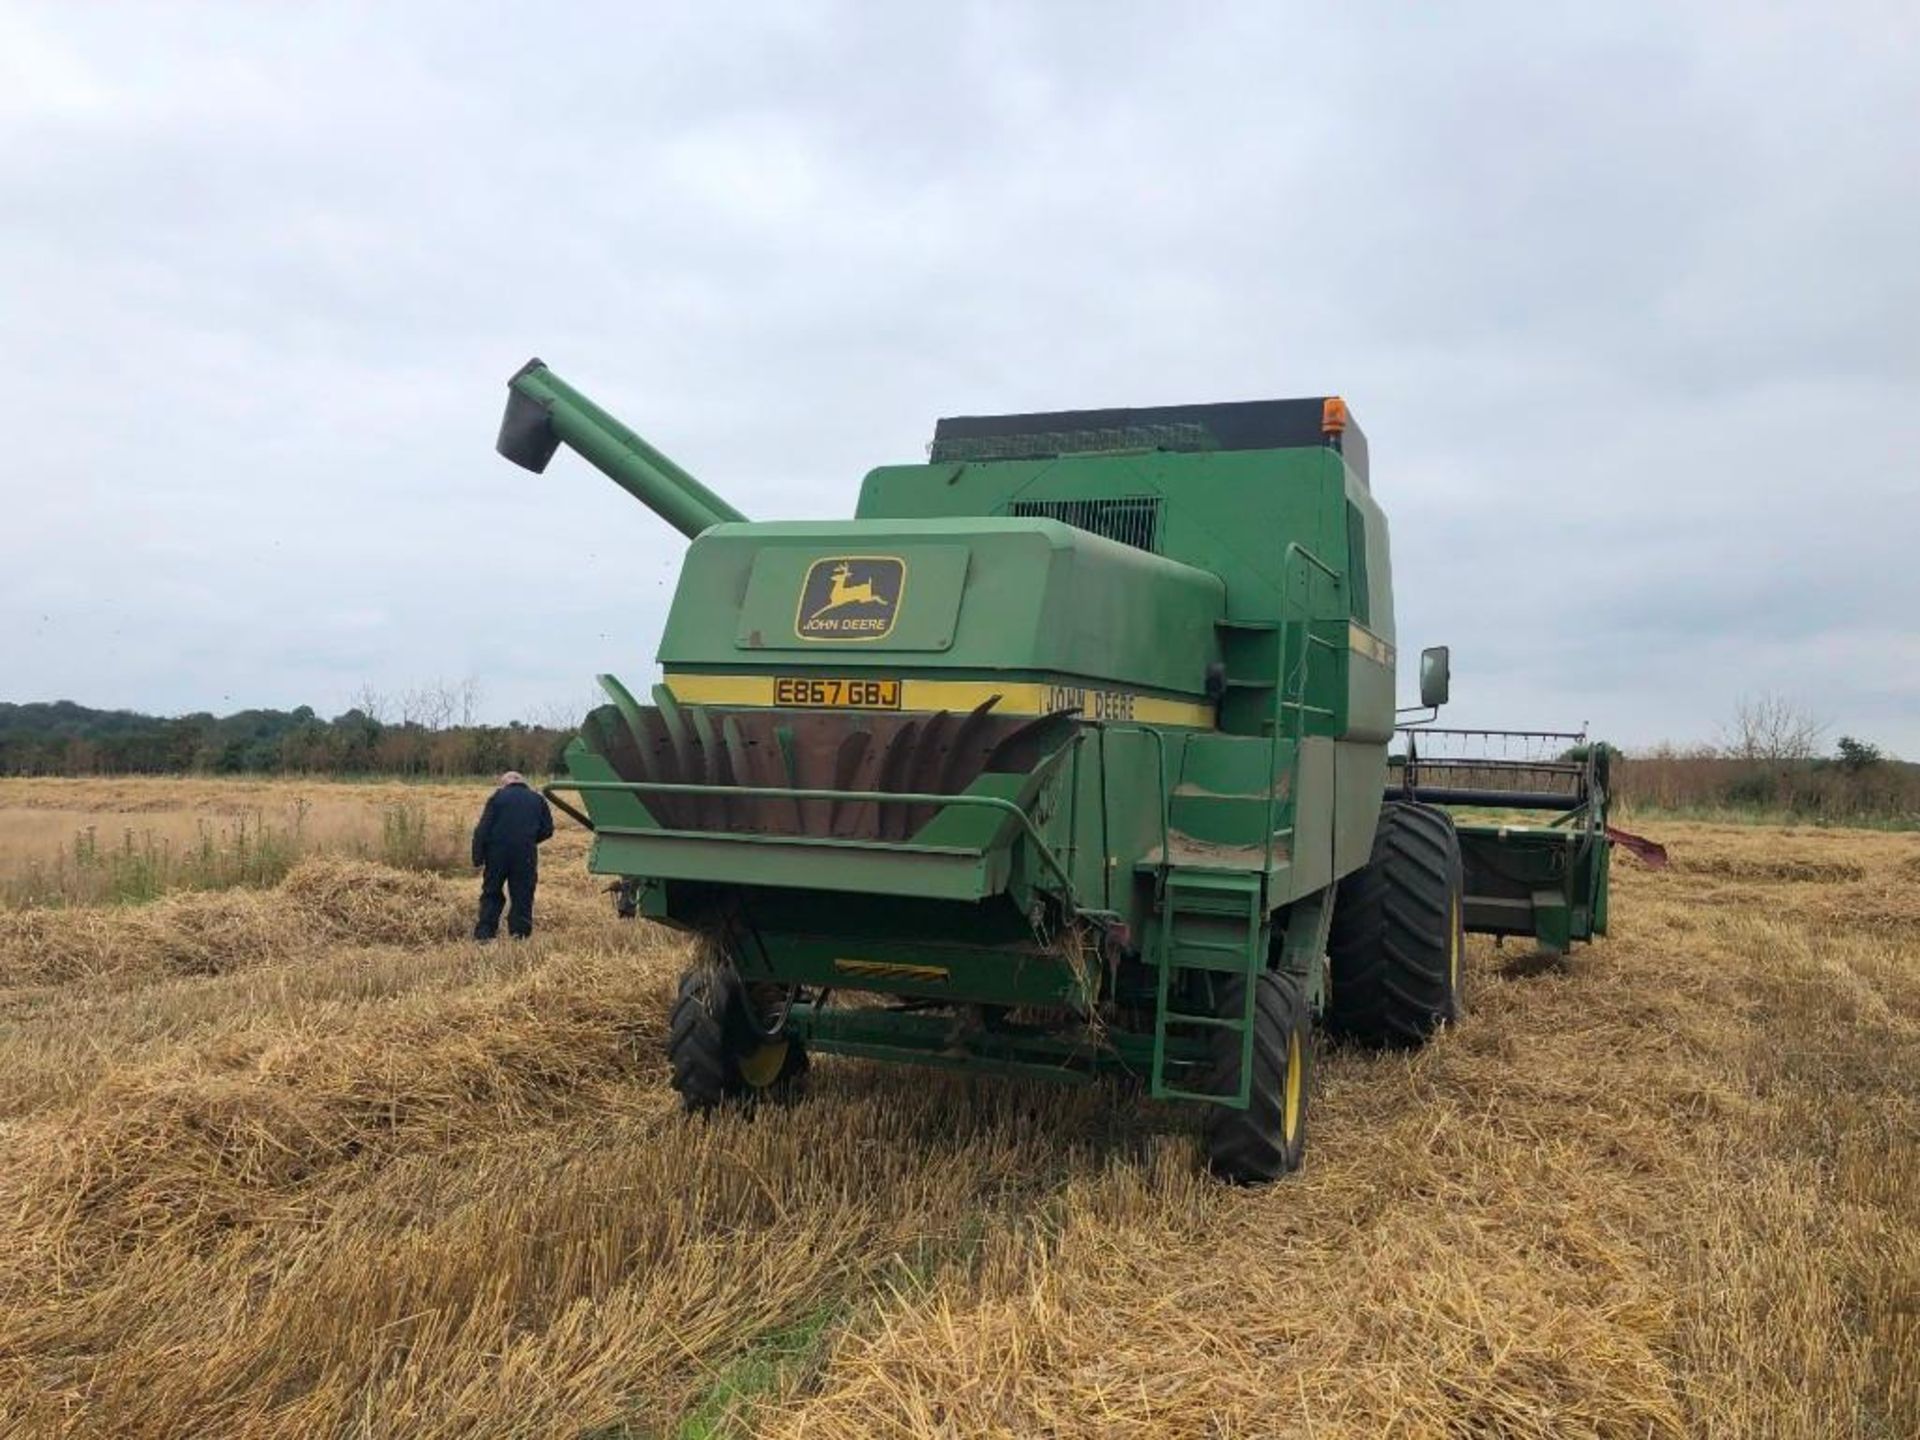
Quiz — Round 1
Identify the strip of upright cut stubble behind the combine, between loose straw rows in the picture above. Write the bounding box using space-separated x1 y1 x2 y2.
0 1075 1136 1440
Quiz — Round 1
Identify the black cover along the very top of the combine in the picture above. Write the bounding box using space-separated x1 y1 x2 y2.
931 396 1367 482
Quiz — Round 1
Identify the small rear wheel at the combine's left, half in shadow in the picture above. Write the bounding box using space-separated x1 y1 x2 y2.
666 966 806 1114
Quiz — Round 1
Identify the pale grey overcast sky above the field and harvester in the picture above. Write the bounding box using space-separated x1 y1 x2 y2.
0 0 1920 756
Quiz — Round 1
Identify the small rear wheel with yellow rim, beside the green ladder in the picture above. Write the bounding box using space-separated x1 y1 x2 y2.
1206 970 1313 1185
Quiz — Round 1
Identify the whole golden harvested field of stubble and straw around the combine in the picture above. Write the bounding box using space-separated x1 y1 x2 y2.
0 781 1920 1440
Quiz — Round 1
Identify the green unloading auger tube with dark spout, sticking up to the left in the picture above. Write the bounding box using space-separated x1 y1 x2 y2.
495 359 747 538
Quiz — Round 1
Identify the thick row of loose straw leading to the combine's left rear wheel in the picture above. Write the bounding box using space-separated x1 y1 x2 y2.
0 950 683 1286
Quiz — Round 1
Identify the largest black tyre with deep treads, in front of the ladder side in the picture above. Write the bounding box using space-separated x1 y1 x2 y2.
1327 801 1467 1048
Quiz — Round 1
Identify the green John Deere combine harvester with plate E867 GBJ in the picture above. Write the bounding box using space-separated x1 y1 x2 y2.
487 361 1643 1181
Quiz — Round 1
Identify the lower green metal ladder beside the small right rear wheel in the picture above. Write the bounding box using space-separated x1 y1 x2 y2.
1148 866 1267 1110
